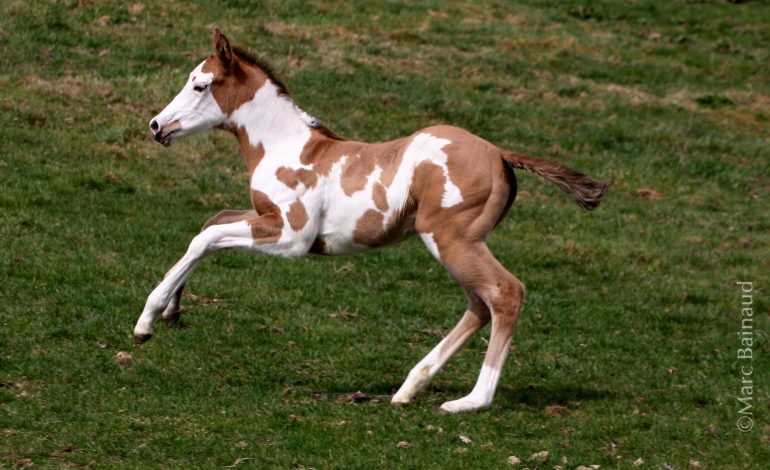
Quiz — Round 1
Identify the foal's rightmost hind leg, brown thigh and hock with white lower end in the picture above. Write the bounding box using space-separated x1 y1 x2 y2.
441 242 524 413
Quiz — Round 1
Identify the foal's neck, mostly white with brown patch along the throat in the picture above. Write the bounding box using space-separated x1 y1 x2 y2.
227 81 313 172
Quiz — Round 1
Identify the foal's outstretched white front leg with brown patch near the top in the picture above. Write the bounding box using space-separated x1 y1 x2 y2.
134 213 292 344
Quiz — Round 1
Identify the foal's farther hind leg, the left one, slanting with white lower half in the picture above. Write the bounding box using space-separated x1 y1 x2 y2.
391 290 489 404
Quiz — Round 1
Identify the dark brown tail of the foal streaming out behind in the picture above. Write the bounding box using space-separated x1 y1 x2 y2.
503 152 610 211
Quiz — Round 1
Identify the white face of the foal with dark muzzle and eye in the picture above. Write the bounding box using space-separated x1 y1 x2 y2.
148 62 226 139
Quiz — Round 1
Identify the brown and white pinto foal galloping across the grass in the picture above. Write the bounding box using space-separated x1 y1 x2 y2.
134 29 607 412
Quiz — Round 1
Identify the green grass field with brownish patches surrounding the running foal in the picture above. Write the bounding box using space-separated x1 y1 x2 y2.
0 0 770 469
